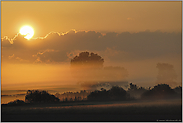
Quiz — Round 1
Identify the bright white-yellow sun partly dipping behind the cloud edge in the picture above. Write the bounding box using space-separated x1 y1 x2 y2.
19 26 34 40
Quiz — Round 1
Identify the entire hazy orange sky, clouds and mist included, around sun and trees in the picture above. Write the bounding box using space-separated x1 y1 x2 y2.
1 1 182 89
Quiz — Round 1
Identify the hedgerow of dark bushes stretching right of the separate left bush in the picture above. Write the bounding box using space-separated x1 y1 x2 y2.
55 83 182 102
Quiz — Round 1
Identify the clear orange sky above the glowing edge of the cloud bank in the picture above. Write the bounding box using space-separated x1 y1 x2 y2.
1 1 182 37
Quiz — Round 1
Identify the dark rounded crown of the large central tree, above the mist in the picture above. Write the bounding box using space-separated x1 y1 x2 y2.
71 52 104 68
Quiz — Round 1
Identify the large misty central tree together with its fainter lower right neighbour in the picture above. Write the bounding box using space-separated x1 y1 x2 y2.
71 51 128 85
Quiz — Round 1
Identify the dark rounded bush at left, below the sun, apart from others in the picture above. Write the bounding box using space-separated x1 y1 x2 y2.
25 90 60 103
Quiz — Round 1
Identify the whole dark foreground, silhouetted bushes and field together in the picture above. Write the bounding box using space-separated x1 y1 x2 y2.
1 83 182 122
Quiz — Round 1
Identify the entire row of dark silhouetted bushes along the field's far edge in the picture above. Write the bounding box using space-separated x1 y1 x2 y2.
3 83 182 105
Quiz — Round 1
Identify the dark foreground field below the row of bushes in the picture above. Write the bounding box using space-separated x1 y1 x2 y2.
1 100 182 122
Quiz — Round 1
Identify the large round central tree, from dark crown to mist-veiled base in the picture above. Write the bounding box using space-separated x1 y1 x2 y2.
71 52 104 83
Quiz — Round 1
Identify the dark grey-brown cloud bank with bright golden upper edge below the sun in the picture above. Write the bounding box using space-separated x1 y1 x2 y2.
2 30 181 63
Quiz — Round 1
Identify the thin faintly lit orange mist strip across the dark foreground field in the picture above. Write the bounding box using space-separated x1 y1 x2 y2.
29 100 181 110
